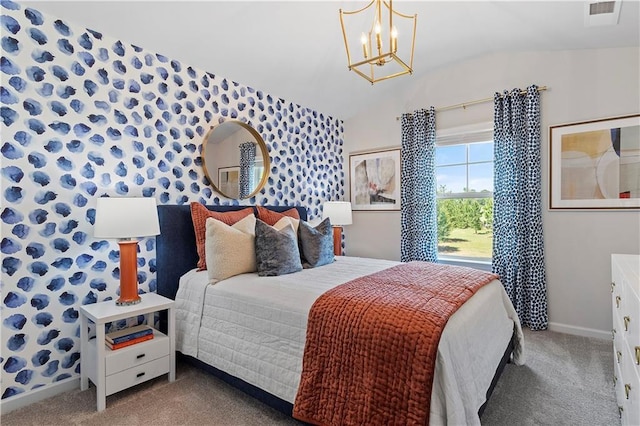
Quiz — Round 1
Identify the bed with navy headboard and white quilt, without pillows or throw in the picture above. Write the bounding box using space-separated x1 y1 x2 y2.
156 205 524 425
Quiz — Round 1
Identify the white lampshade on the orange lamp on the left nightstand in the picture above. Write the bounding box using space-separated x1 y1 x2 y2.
93 197 160 238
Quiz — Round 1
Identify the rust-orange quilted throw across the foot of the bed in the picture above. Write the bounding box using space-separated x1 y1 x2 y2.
293 262 497 425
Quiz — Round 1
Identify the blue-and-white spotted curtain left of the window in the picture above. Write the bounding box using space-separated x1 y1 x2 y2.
400 107 438 262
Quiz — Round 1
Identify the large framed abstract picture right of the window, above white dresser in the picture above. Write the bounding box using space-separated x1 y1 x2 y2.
549 114 640 209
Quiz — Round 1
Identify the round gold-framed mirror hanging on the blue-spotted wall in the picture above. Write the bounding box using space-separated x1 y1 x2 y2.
202 120 269 199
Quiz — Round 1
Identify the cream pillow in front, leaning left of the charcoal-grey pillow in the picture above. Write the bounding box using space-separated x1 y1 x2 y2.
205 215 256 280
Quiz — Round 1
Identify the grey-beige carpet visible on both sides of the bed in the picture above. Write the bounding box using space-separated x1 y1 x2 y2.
0 330 619 426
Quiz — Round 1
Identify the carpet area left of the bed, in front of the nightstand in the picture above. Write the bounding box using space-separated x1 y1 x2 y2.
0 363 299 426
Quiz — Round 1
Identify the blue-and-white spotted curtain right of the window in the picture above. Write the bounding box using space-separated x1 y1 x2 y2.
492 86 548 330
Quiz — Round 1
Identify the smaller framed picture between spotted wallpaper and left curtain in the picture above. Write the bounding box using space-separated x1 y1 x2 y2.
349 149 400 210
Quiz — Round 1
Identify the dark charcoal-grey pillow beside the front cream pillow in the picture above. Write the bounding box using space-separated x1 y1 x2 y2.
256 219 302 277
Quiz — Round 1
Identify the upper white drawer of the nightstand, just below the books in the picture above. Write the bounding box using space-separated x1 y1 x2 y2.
105 330 169 376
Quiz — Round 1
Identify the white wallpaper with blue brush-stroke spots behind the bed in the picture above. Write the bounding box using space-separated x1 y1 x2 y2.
0 0 344 398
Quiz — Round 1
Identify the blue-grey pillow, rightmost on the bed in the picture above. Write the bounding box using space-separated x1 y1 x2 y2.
299 218 335 268
